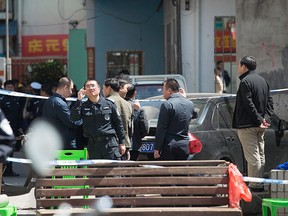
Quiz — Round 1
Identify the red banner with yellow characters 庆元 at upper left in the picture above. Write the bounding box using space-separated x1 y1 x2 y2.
22 35 68 57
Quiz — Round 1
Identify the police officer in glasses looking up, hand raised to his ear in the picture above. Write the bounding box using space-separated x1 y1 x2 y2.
71 80 126 160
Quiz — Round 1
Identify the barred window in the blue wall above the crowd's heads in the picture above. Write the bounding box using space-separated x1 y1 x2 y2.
107 50 144 77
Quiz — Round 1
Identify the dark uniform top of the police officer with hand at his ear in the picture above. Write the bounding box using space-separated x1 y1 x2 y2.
71 96 125 144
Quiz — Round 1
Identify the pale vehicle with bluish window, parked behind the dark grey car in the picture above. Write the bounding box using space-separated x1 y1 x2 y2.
129 74 187 99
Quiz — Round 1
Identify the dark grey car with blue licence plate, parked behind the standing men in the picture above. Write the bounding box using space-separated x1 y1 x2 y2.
140 91 288 174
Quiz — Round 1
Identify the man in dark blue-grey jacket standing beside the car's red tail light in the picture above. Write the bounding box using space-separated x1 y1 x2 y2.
154 78 195 160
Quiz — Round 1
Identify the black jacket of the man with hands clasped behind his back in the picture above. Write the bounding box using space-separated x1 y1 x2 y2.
233 71 273 128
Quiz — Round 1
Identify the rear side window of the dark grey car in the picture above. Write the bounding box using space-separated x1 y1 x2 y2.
212 98 235 129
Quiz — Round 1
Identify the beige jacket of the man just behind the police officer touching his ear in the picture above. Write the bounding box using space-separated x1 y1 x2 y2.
108 92 132 149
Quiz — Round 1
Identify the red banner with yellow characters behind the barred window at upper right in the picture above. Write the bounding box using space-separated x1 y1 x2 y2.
215 30 236 53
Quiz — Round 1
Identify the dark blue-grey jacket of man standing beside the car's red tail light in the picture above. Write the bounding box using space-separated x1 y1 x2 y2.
154 93 194 151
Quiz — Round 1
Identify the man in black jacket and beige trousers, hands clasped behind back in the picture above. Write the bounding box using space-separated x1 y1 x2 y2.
233 56 273 191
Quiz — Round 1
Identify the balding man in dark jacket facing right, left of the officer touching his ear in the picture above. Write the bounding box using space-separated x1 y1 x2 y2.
43 77 82 149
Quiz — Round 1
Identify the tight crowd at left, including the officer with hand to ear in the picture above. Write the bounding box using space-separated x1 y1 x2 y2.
0 72 148 166
